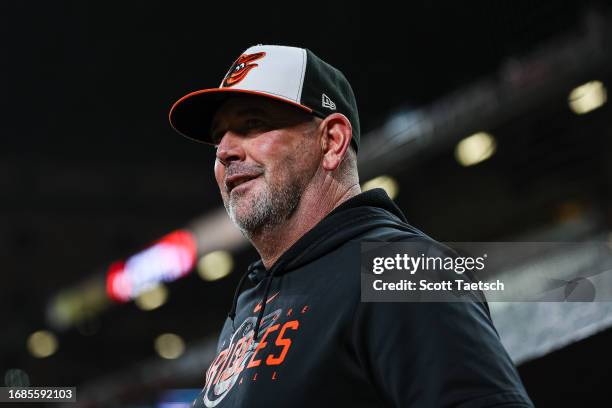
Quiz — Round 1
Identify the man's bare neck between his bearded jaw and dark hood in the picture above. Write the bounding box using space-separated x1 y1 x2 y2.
249 183 361 269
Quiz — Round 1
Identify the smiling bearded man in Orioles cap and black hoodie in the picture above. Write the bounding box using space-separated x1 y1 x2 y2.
170 45 532 407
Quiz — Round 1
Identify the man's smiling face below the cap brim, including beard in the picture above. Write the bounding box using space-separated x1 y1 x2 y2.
212 96 321 233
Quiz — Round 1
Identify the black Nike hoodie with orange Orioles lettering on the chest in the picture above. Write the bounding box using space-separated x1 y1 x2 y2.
194 189 532 408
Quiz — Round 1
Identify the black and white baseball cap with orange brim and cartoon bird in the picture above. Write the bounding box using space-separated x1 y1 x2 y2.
169 45 360 151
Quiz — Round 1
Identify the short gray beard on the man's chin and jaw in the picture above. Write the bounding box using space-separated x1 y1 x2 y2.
224 176 304 237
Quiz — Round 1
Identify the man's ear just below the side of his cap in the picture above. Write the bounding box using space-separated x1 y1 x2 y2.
320 113 353 171
